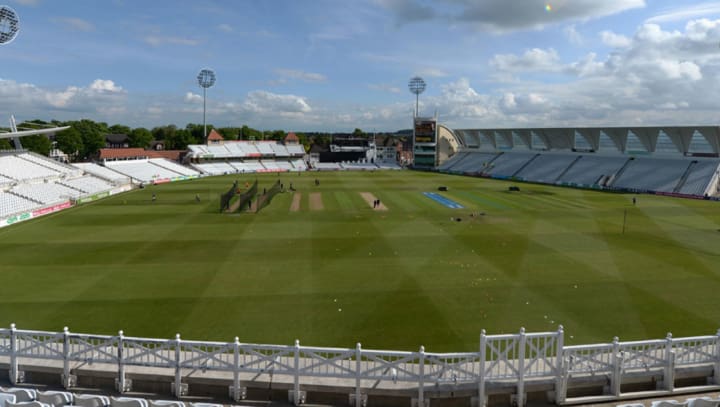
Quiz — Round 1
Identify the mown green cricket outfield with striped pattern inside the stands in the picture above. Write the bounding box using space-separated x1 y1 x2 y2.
0 171 720 351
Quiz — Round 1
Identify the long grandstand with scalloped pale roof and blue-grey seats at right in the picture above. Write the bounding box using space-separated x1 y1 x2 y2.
437 126 720 197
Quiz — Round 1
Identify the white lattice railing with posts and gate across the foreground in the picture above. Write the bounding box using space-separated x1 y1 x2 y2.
0 324 720 406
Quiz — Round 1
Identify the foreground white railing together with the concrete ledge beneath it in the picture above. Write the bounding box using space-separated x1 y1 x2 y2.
0 325 720 406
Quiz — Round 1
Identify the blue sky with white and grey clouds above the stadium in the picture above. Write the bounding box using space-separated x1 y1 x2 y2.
0 0 720 131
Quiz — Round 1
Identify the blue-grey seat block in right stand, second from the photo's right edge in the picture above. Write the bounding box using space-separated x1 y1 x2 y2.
612 158 690 192
